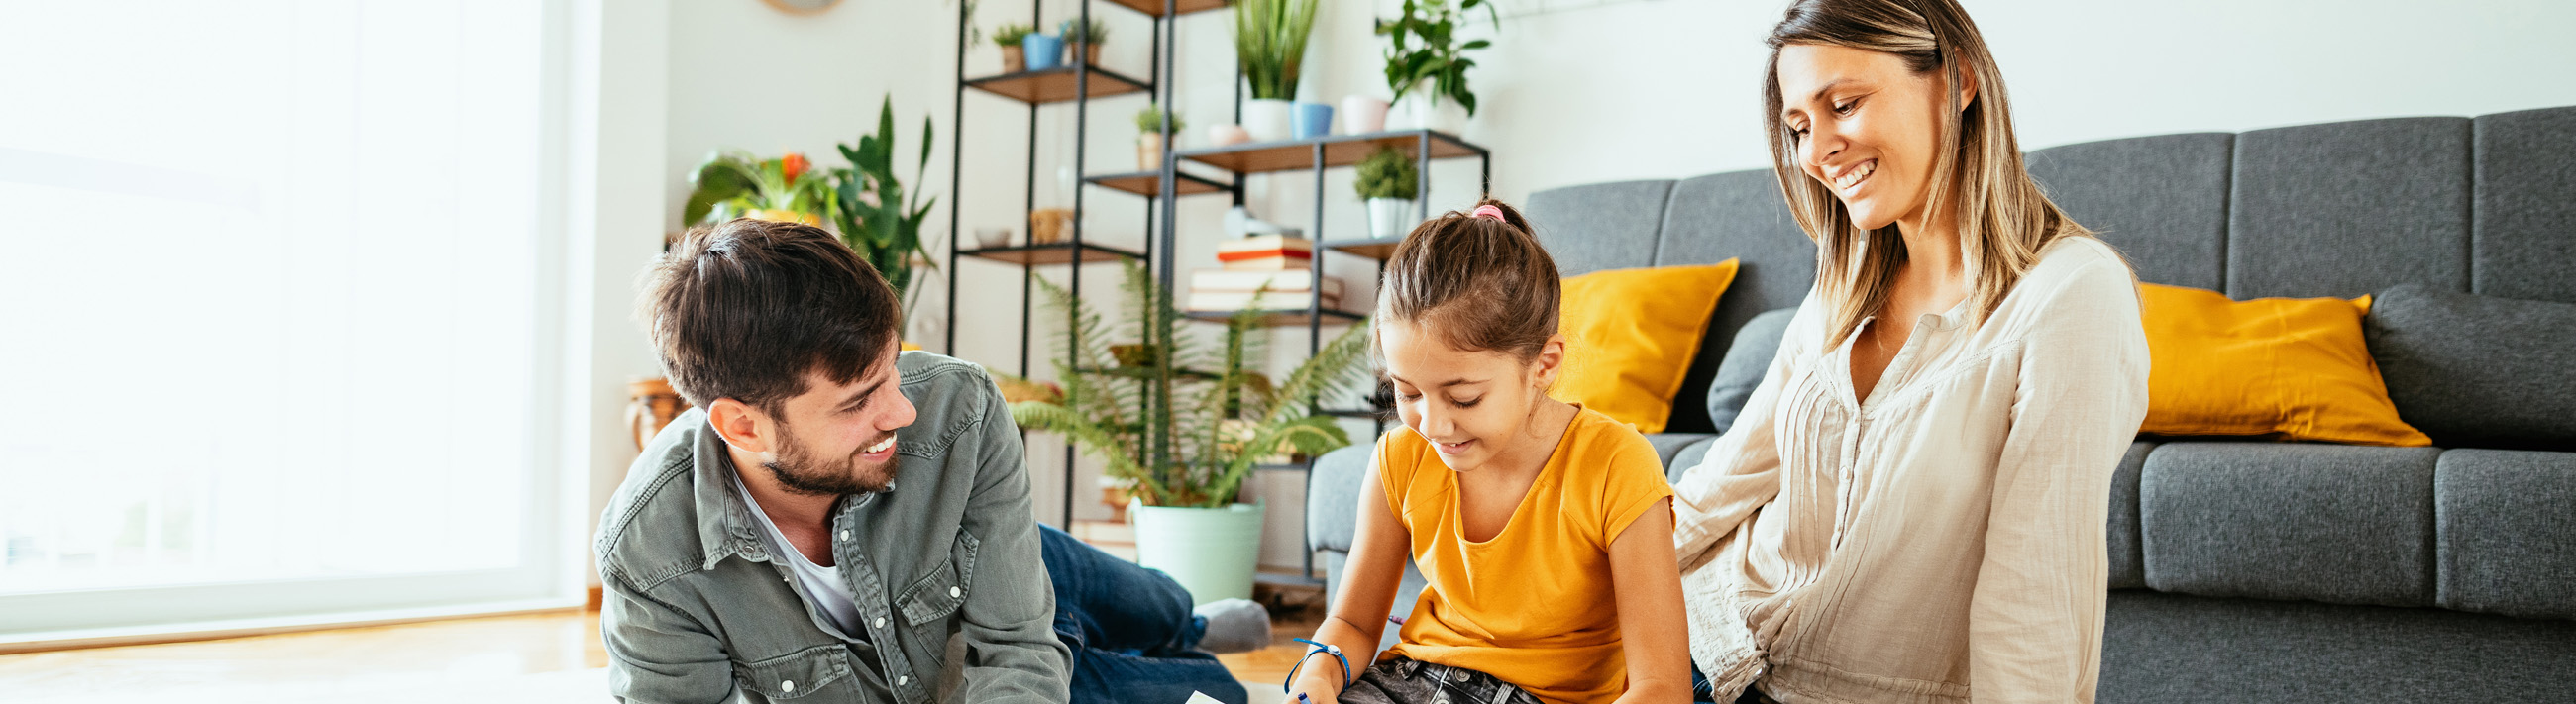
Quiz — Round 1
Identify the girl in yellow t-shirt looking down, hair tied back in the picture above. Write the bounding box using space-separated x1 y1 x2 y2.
1288 201 1690 704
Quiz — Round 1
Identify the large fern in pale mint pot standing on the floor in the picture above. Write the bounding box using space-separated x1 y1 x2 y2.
1010 263 1368 603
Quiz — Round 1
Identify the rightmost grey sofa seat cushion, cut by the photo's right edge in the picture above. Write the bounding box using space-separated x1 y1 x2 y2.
2431 449 2576 619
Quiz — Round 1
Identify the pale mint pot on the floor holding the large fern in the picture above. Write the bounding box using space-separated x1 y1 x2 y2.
1128 500 1262 606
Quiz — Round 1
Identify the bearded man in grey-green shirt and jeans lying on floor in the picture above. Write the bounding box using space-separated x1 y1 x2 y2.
597 219 1267 704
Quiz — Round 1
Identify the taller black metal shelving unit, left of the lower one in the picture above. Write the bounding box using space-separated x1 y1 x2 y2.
945 0 1241 529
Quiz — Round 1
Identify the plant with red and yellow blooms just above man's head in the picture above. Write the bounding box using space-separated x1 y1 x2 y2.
680 150 840 225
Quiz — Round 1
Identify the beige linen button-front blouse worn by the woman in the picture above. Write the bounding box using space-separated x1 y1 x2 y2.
1674 238 2148 704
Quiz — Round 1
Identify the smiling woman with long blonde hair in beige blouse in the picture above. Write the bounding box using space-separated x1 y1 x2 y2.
1674 0 2146 701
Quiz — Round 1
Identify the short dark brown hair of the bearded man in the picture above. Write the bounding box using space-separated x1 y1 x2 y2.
644 217 902 410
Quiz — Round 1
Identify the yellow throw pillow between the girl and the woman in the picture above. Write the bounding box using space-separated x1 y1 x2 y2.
1554 260 1736 434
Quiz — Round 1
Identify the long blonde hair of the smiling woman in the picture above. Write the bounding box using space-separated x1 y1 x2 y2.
1762 0 2092 346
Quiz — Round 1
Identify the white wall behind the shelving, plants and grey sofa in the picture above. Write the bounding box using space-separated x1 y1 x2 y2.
618 0 2576 564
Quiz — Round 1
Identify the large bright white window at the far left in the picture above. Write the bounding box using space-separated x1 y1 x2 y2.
0 0 557 635
